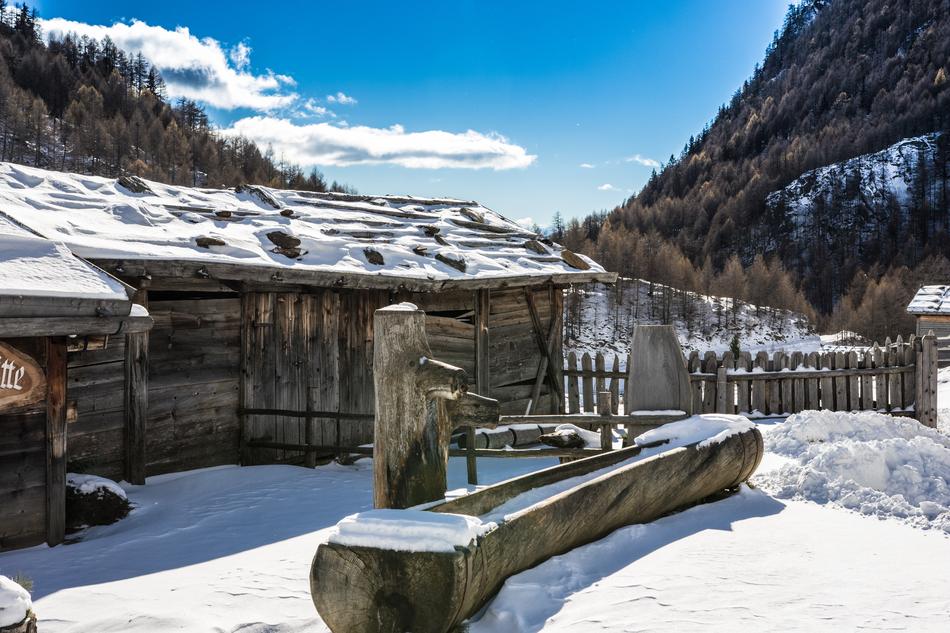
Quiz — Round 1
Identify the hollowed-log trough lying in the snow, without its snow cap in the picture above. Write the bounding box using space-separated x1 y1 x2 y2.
310 420 763 633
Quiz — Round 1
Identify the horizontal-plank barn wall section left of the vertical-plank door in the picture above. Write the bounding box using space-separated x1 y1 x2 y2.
147 292 241 475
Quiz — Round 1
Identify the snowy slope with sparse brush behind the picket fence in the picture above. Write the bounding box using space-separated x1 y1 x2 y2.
564 280 821 363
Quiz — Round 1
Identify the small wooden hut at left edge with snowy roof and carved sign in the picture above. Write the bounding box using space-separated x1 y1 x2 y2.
0 218 151 550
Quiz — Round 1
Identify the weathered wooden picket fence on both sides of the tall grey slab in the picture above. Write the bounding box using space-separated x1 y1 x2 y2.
564 335 938 426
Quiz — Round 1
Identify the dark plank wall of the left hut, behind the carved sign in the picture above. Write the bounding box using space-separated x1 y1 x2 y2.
0 338 46 550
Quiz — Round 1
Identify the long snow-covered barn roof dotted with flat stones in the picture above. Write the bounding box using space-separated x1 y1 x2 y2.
0 163 613 292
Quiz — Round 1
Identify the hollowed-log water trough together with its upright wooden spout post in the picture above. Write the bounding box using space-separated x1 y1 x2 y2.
310 316 763 633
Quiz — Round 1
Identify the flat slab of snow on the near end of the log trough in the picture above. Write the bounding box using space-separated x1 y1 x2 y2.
327 509 497 553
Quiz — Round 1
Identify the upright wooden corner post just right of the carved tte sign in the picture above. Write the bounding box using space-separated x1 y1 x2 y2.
46 337 67 546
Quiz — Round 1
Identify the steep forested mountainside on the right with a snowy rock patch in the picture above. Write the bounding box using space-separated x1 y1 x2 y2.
563 0 950 336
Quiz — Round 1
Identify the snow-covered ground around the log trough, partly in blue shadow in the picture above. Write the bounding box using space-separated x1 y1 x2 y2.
0 400 950 633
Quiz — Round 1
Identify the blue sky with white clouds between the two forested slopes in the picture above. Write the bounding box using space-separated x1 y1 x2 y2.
35 0 787 224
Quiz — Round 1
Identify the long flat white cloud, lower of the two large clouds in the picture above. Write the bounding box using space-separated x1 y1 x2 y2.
222 116 537 170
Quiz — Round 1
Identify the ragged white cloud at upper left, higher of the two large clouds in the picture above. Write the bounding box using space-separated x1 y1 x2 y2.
40 18 297 112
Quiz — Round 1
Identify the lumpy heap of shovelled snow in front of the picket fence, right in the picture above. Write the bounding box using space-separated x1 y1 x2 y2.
755 411 950 533
